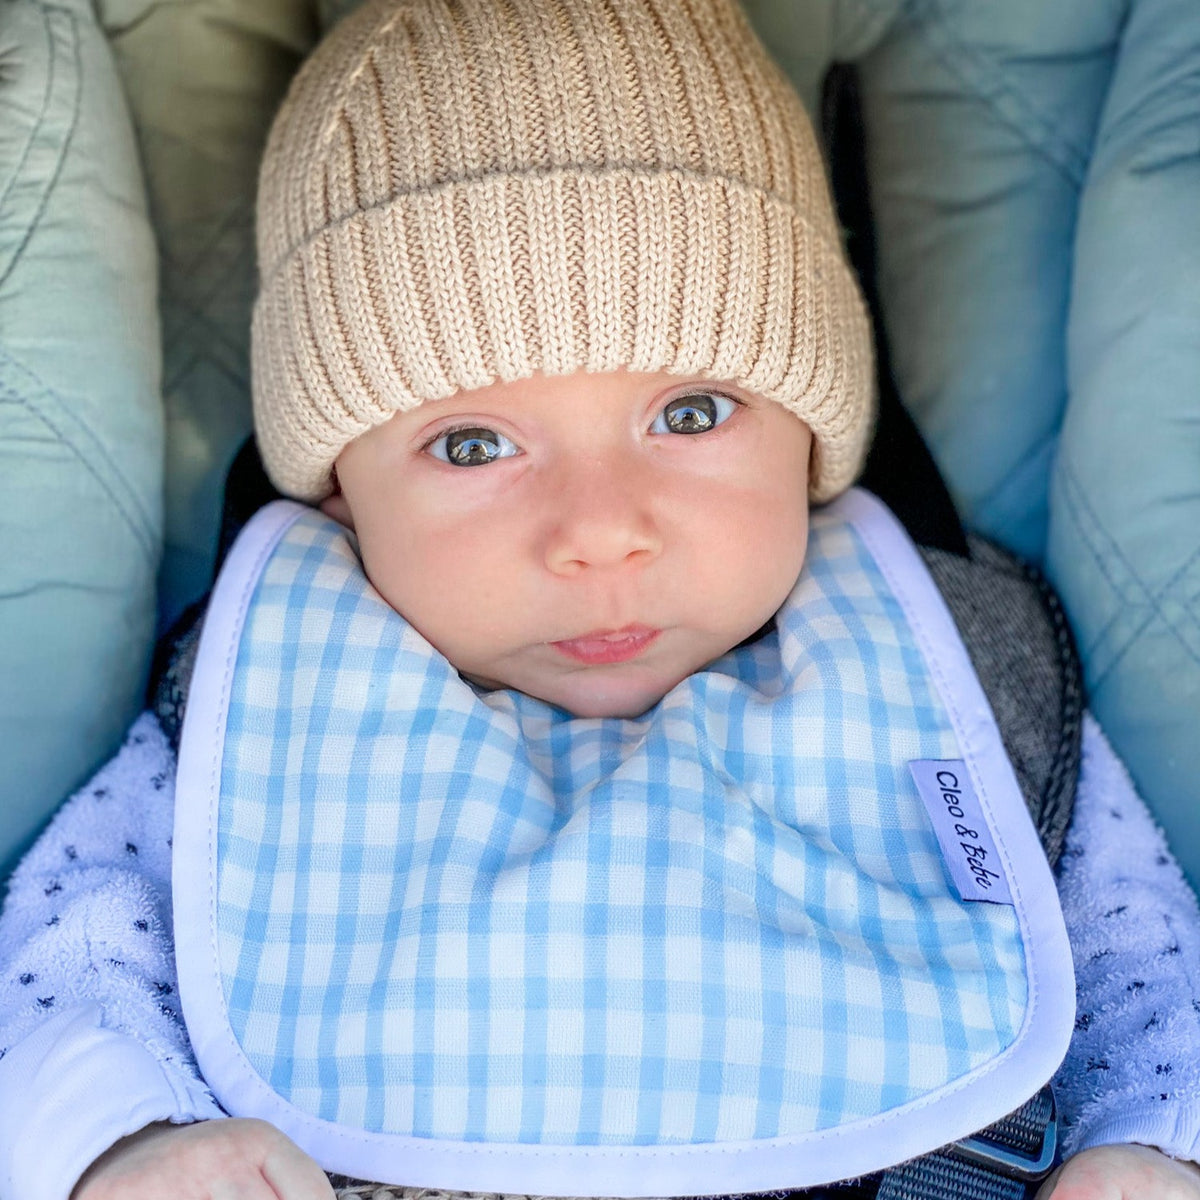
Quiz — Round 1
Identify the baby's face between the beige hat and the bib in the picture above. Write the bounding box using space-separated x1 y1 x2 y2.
323 372 811 716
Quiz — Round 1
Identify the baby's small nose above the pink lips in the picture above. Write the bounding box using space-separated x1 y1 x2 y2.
546 462 662 575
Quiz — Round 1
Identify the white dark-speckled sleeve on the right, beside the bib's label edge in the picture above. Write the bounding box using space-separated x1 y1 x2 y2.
1055 718 1200 1160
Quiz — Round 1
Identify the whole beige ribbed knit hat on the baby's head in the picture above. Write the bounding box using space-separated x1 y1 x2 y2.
253 0 872 500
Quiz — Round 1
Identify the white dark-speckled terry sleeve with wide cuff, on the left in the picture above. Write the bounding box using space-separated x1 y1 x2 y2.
0 715 223 1200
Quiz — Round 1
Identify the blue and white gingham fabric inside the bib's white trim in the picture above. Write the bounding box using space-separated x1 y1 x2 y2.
217 514 1026 1145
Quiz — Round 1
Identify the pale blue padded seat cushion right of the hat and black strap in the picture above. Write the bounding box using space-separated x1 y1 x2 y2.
835 0 1200 883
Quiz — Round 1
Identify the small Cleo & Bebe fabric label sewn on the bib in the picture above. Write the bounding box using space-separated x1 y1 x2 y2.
908 758 1013 905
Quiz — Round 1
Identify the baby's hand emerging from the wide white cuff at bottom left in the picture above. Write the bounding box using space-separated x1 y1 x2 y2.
71 1118 334 1200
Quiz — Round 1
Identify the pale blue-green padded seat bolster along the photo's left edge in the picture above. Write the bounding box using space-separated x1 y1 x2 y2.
0 0 162 875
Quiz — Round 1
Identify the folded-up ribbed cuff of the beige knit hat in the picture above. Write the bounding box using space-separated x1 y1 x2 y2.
253 166 872 502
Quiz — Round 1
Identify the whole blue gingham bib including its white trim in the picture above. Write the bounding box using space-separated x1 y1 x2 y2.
174 492 1074 1195
